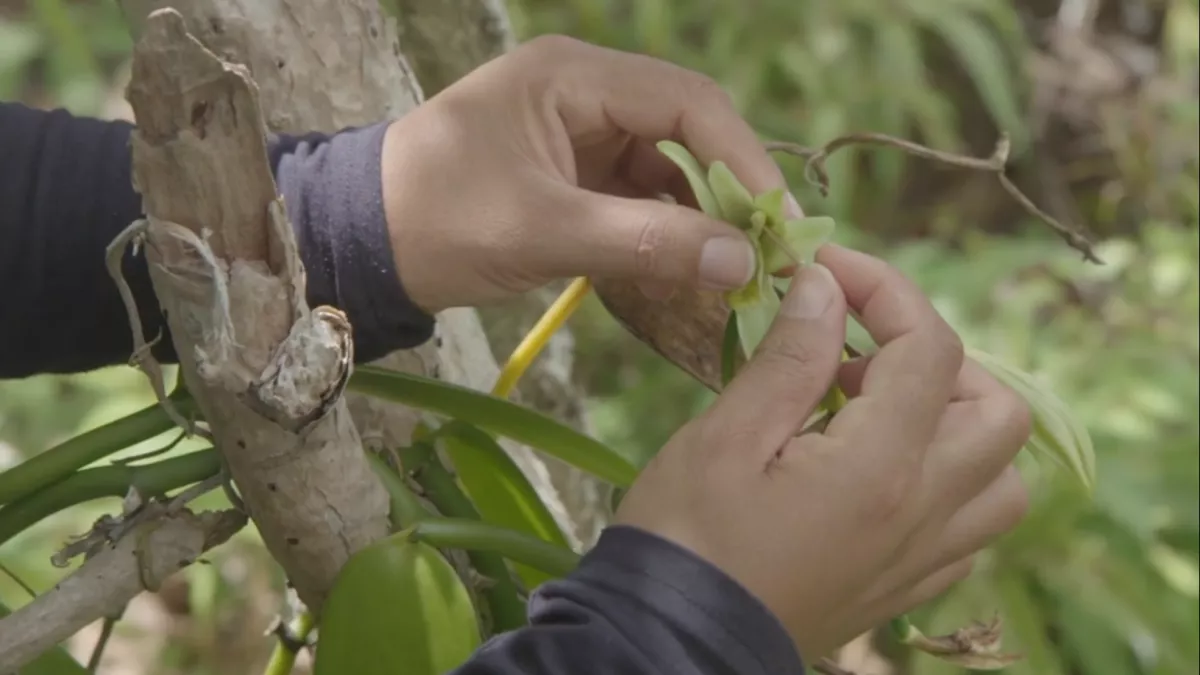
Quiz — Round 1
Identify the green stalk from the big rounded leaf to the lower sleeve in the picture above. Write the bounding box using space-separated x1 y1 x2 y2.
403 518 580 577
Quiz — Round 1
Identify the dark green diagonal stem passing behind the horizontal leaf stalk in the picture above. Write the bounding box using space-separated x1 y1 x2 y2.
401 443 527 633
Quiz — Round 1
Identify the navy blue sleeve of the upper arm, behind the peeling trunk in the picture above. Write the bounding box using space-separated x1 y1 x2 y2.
0 103 433 378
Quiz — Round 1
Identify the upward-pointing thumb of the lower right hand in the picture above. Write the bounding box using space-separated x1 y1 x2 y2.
714 263 846 452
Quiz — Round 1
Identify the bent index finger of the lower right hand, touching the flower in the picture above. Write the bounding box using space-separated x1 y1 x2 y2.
817 245 964 455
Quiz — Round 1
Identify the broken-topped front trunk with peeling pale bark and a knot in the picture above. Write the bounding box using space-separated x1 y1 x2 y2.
117 10 388 611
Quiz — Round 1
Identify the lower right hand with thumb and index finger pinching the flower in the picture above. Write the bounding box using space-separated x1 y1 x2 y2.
617 245 1031 661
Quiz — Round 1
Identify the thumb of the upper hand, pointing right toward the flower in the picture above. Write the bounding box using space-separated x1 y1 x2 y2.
539 187 755 291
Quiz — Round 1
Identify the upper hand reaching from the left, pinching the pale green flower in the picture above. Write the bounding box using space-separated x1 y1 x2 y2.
382 36 803 312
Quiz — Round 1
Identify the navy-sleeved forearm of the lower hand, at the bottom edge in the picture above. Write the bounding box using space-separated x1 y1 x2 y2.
450 526 804 675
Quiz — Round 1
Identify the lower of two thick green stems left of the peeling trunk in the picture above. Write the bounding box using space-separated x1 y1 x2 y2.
0 448 221 546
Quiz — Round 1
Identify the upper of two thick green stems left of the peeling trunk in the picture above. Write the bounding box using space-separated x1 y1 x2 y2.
0 393 194 506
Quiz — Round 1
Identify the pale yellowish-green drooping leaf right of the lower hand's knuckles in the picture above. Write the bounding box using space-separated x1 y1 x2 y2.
967 347 1096 494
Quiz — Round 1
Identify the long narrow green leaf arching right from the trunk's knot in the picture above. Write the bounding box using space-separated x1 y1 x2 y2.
349 366 640 488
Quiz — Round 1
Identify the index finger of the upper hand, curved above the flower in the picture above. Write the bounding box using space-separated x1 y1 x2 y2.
527 36 803 212
